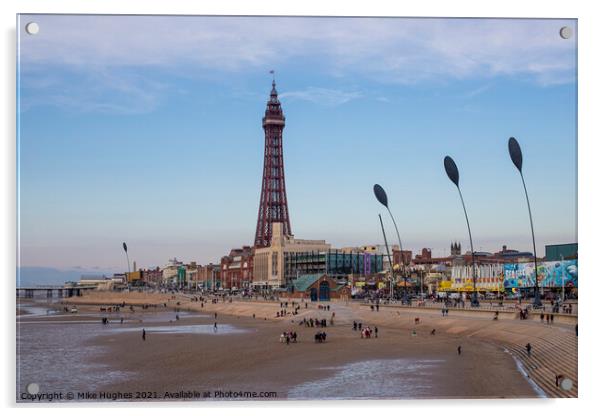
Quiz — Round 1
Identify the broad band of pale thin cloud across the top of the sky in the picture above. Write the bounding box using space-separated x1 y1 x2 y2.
21 15 576 82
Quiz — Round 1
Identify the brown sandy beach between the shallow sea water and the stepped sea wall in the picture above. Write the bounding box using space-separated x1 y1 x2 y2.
48 294 537 399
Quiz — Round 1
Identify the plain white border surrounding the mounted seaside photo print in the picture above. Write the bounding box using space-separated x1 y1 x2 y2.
0 0 602 415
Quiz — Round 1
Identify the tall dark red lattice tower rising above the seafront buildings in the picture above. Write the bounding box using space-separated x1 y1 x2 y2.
255 80 291 247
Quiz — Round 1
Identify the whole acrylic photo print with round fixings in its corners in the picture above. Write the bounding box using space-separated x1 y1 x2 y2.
16 14 578 403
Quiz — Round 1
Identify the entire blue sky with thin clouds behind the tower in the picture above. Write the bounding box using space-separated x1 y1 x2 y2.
18 15 577 270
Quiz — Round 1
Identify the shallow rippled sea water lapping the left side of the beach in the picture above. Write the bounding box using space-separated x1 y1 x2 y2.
16 302 245 401
